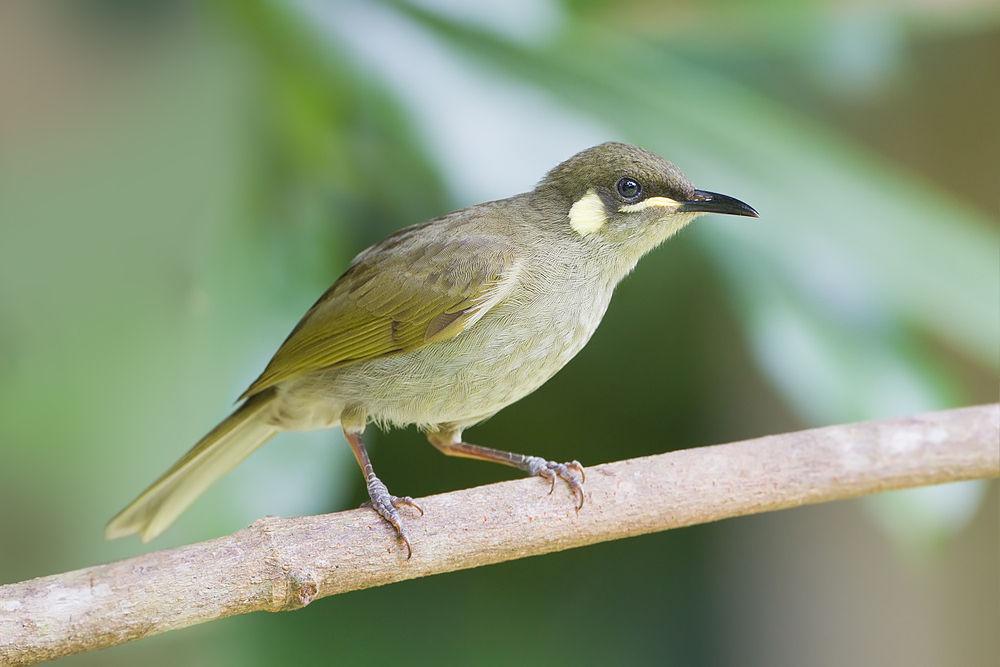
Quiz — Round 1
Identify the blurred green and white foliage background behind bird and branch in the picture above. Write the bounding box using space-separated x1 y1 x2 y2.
0 0 1000 666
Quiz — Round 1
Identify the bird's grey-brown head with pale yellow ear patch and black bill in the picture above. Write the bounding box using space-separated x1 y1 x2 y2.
532 142 757 263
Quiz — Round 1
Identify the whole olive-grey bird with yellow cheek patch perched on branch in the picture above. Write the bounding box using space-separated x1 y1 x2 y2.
105 142 758 559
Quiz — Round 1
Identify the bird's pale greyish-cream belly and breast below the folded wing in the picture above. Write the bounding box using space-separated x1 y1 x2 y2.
310 300 607 425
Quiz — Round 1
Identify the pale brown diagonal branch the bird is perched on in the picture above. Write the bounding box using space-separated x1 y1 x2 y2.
0 404 1000 664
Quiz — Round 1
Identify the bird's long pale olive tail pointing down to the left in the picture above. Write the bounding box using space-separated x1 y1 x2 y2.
104 391 277 542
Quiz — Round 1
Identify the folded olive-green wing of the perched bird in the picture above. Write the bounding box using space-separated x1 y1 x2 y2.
241 236 520 398
